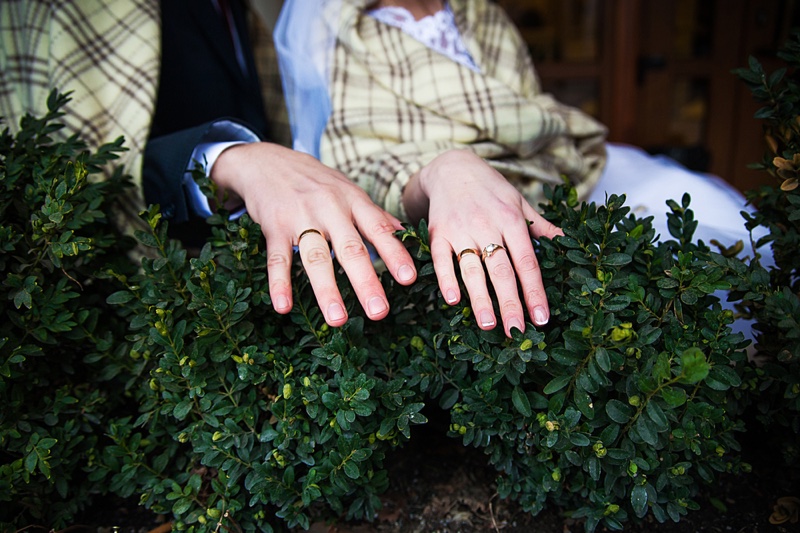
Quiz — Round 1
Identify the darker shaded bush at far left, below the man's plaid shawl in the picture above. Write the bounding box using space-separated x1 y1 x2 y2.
0 93 136 529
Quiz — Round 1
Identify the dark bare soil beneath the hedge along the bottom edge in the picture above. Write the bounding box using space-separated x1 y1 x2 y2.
75 410 800 533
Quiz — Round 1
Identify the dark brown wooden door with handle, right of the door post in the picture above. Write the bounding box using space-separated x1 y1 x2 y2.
634 0 792 190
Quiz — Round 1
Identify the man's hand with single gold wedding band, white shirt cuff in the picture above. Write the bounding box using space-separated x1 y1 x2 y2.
211 143 417 326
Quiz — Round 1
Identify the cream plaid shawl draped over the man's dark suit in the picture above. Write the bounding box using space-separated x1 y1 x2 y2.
0 0 290 224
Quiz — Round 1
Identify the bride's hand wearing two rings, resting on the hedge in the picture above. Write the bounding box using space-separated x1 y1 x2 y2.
403 150 563 336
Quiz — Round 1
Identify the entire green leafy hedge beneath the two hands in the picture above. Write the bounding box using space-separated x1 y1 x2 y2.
0 31 800 531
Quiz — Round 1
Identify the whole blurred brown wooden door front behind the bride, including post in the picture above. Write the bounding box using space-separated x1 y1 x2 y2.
497 0 800 191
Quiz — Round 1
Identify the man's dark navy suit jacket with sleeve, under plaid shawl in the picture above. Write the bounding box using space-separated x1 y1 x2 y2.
142 0 267 238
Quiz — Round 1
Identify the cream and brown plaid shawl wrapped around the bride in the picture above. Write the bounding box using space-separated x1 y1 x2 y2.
321 0 606 218
